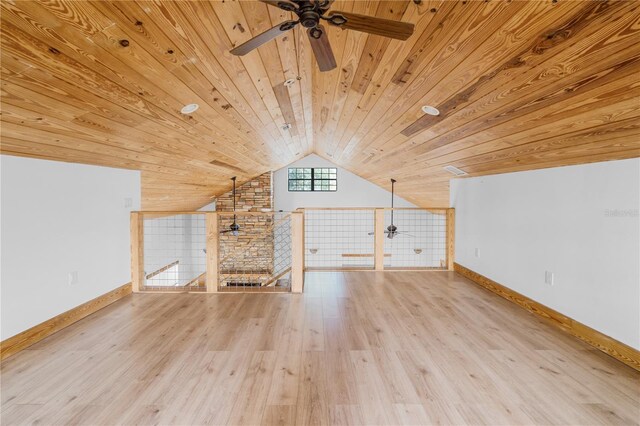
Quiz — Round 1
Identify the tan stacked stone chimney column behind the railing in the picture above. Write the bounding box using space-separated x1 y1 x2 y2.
216 172 274 274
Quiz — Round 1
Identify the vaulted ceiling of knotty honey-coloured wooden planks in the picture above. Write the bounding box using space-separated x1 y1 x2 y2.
1 0 640 210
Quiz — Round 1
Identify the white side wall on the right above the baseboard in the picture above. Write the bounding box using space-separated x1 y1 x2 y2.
451 159 640 348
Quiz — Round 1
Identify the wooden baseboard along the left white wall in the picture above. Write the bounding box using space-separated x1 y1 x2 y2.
0 283 131 360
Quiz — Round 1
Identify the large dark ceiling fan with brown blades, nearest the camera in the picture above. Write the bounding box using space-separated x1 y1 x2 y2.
231 0 413 71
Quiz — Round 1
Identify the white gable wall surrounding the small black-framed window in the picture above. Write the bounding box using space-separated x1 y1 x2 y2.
273 154 415 211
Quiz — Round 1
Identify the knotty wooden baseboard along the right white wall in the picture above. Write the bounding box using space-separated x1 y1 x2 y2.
454 263 640 371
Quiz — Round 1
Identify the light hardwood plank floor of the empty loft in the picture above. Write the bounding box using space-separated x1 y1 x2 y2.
1 272 640 425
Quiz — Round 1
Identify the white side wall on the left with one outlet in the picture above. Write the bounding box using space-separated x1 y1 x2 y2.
0 155 140 340
